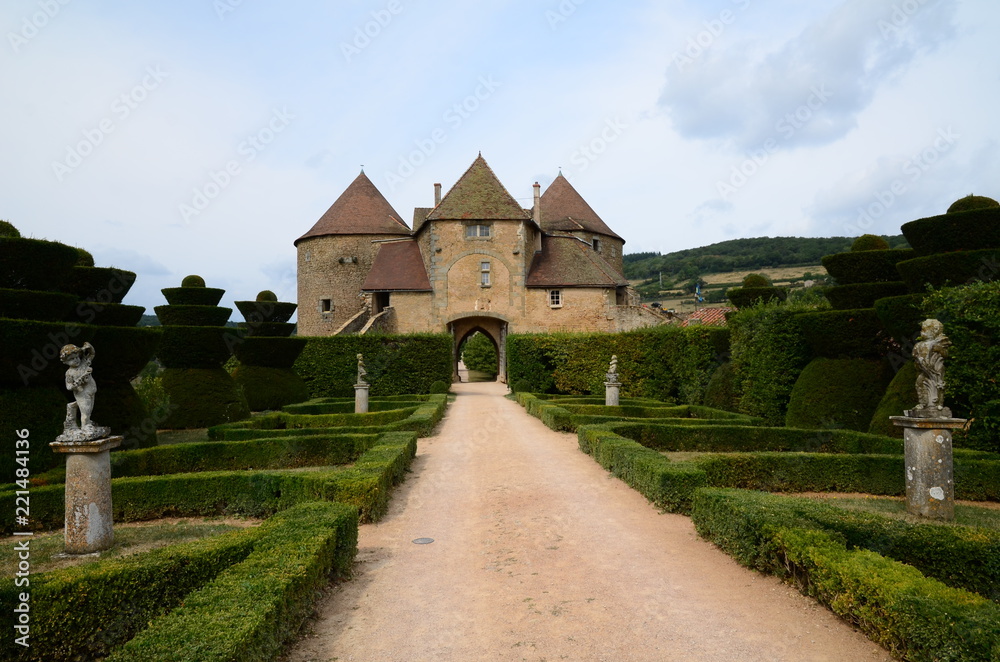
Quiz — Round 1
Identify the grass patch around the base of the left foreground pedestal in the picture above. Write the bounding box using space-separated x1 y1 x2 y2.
0 517 249 577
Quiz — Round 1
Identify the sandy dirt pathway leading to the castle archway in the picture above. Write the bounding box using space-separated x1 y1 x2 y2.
288 383 892 662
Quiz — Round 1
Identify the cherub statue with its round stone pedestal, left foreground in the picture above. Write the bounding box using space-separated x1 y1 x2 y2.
49 343 123 554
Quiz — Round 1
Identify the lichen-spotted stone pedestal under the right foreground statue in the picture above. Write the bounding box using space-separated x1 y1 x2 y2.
889 418 966 521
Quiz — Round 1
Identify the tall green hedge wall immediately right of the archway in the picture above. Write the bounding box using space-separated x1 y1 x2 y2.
507 326 729 404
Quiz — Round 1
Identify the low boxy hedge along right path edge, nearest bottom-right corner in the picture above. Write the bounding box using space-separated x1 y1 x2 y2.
692 490 1000 662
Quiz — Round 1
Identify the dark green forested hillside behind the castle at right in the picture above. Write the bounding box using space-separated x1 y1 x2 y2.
625 235 907 280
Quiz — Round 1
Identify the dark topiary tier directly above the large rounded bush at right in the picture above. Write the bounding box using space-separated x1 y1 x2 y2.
796 310 886 359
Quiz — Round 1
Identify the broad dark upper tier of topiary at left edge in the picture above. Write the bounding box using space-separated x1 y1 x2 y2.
0 236 80 291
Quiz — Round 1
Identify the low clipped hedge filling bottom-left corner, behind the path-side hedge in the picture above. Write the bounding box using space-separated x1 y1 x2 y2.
0 528 264 662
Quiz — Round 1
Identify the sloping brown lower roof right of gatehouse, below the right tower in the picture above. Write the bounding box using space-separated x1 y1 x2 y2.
525 235 628 287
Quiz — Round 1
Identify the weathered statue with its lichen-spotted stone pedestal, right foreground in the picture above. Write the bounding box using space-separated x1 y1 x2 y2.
889 319 966 521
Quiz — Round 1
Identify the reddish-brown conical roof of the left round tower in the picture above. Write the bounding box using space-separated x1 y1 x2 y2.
295 172 410 244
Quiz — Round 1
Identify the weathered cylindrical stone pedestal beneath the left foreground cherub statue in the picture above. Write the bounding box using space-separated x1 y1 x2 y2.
49 437 123 554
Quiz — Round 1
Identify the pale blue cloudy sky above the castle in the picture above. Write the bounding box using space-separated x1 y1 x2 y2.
0 0 1000 319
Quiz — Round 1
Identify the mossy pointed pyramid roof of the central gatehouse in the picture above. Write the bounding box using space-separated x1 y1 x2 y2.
427 154 531 221
